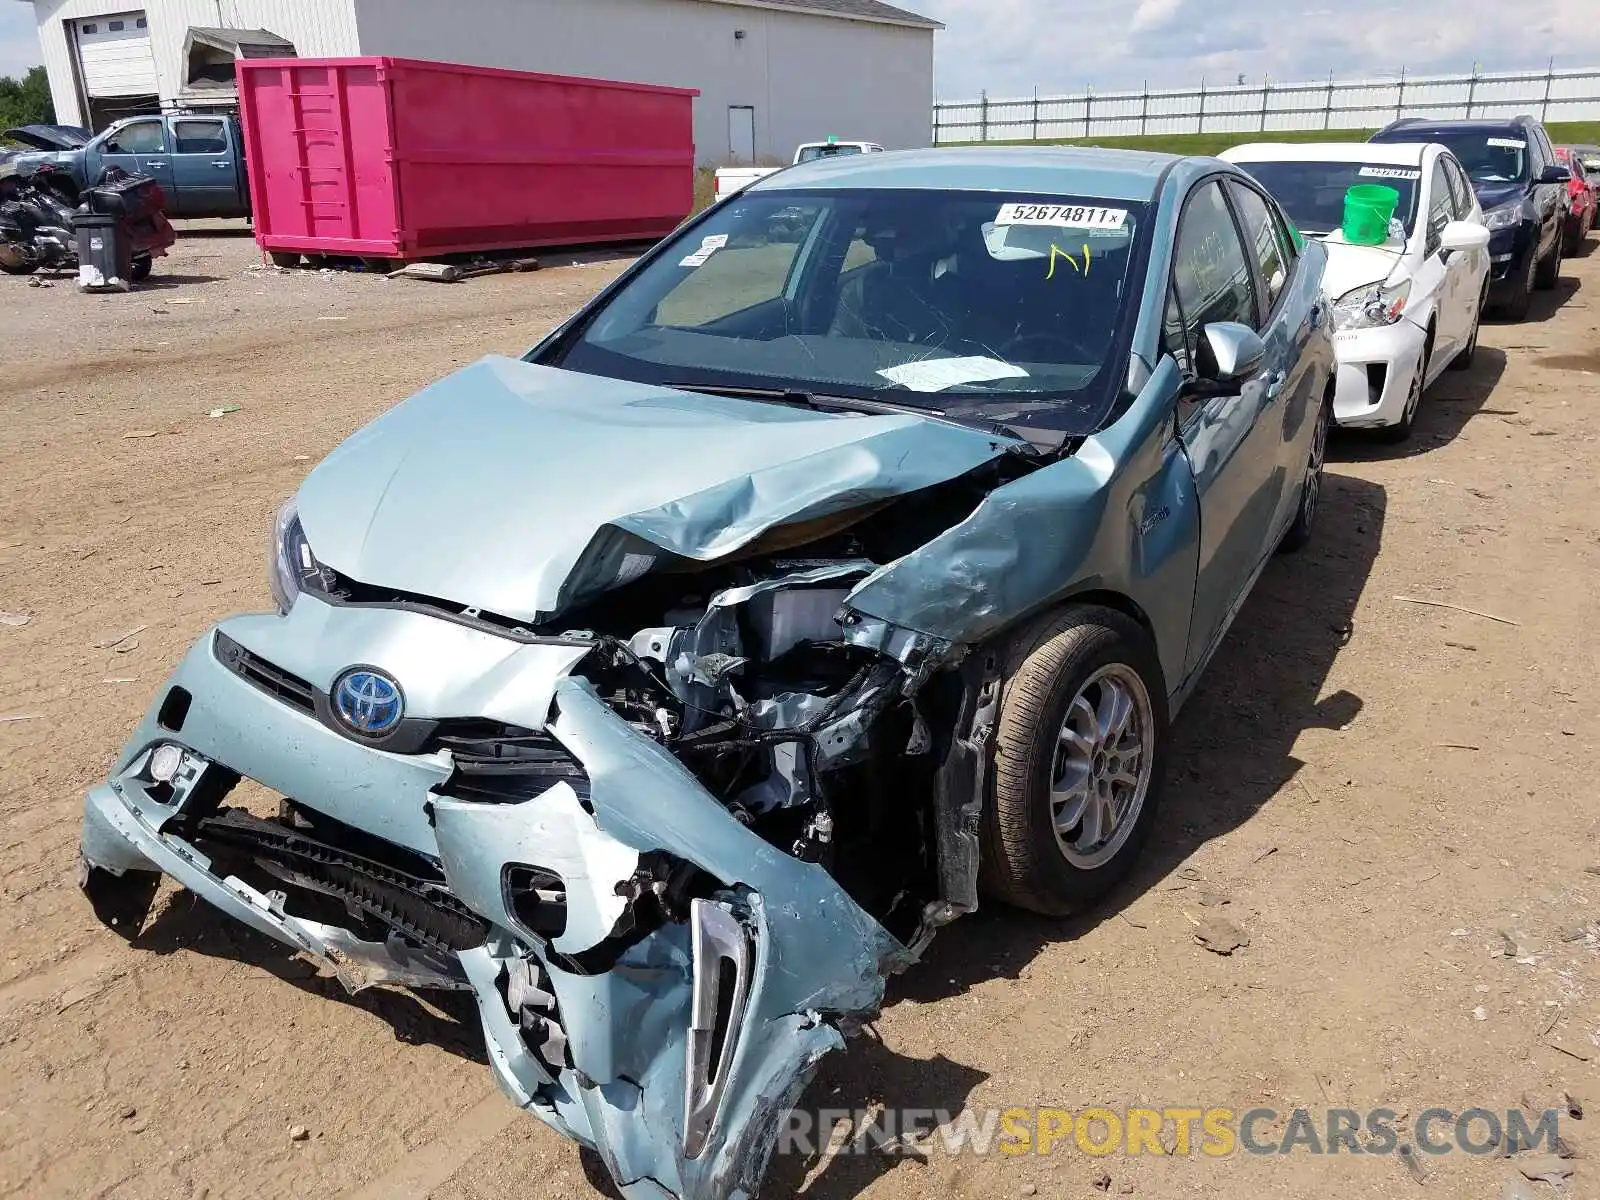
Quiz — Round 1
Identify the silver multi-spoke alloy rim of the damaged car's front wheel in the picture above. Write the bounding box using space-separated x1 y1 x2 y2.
1050 662 1155 870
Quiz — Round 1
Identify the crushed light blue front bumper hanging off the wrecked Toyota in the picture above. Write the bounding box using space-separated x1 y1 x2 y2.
82 597 909 1200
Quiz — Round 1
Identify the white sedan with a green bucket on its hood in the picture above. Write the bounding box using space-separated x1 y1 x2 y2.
1221 142 1490 442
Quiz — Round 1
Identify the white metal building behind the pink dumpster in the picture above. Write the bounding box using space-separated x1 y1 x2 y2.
22 0 942 163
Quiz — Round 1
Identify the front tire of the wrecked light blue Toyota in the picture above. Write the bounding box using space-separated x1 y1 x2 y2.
981 605 1168 917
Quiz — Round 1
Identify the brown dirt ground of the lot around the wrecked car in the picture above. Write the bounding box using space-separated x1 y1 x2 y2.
0 227 1600 1200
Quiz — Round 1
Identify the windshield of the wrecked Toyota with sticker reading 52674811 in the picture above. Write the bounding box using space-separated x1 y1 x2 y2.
562 190 1142 424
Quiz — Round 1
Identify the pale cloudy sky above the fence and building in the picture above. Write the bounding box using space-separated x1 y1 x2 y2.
0 0 1600 99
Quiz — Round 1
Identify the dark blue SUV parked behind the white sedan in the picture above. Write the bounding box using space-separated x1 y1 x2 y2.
1371 117 1570 320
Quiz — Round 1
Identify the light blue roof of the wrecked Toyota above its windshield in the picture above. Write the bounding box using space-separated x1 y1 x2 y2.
746 146 1184 202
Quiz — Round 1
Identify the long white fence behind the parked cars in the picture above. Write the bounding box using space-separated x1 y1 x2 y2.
933 67 1600 144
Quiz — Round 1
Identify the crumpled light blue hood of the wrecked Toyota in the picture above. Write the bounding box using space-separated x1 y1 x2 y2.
299 355 1019 622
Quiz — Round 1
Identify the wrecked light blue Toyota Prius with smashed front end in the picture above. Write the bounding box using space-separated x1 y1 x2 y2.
82 150 1333 1200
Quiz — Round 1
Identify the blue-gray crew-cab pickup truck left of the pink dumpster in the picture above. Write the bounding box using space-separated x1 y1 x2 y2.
14 112 250 216
